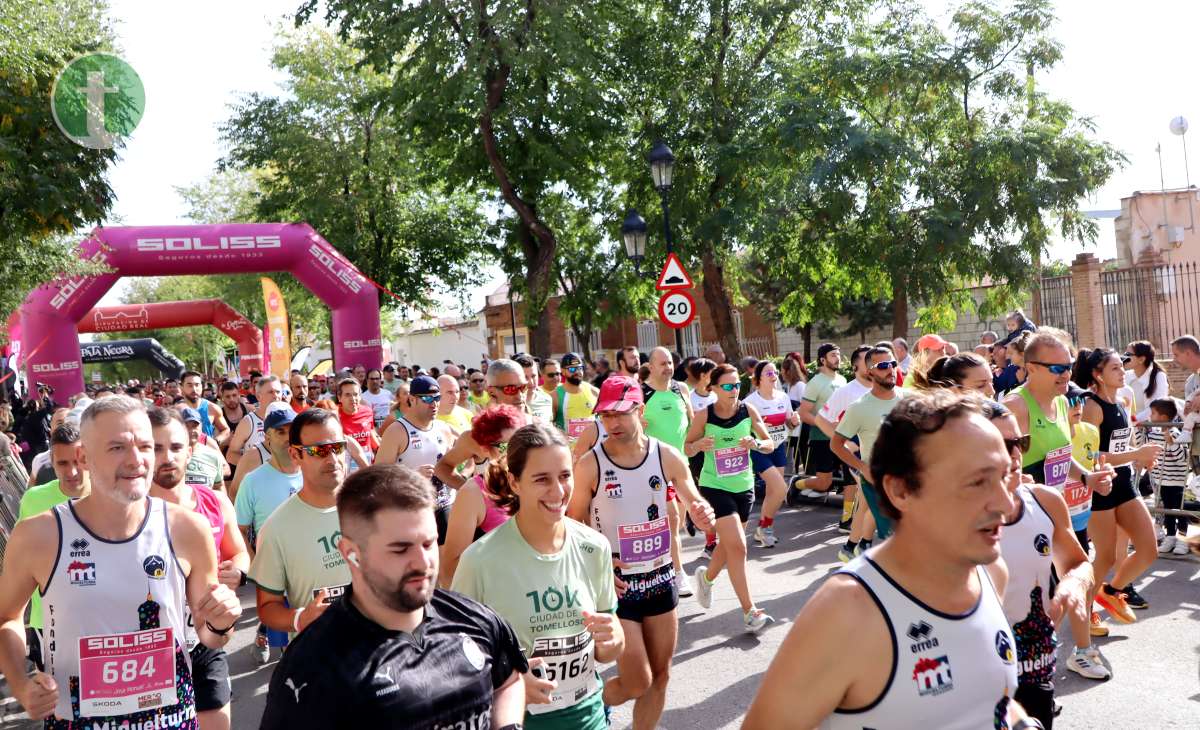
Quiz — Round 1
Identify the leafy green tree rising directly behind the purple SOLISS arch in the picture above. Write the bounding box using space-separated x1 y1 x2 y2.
222 28 492 316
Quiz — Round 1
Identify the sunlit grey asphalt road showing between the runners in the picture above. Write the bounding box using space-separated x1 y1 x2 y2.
0 507 1200 730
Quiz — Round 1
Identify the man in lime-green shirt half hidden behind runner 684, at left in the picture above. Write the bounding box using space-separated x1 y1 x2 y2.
17 423 91 671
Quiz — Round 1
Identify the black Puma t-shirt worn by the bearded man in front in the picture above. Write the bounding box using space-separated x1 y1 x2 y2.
262 588 528 730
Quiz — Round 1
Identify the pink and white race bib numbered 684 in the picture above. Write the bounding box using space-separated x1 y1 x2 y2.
78 627 179 717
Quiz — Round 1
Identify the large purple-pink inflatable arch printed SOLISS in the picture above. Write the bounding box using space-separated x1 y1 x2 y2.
20 223 383 394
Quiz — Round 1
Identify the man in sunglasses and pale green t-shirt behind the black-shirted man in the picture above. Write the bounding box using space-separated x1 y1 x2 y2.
250 408 358 639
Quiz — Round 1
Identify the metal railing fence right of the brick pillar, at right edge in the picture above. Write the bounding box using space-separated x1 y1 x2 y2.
1100 263 1200 352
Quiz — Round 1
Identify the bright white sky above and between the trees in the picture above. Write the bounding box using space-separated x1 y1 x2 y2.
104 0 1200 306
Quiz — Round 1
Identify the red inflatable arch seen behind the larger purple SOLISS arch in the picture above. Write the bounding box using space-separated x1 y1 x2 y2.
78 299 265 379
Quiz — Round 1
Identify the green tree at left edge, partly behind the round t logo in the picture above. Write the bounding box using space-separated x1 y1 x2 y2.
0 0 118 324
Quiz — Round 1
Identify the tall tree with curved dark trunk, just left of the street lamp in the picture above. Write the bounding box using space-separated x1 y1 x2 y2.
296 0 630 357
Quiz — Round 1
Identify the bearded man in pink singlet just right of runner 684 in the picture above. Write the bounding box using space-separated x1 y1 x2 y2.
148 408 250 730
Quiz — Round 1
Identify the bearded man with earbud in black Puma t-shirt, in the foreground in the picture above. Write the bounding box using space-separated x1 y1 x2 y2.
262 465 528 730
